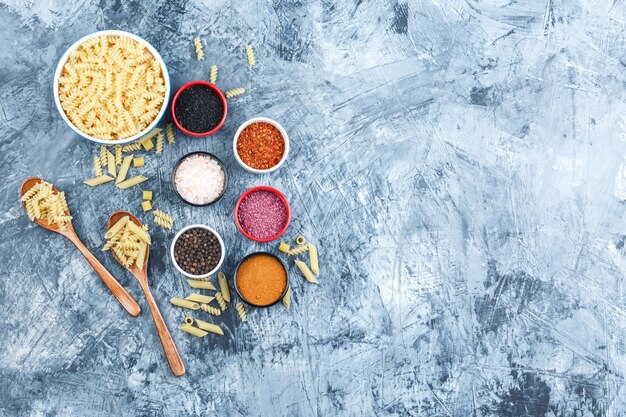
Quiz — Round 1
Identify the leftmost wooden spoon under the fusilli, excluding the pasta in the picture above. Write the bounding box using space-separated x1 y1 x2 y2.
20 178 141 317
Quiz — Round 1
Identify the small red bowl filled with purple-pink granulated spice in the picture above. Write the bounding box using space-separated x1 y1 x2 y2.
234 185 291 242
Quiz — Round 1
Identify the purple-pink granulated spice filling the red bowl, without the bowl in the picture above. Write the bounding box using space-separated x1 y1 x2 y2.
238 190 287 239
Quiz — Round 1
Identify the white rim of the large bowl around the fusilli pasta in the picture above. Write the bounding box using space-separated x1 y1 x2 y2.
53 30 171 145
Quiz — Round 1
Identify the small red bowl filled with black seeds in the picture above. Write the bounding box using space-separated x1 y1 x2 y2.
172 80 228 137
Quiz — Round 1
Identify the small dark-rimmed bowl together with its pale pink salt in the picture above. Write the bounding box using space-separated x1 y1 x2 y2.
172 151 228 207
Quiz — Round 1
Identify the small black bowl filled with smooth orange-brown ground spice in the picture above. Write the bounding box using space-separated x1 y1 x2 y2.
233 251 289 308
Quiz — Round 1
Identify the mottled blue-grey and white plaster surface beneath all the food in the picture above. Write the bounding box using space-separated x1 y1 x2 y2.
0 0 626 416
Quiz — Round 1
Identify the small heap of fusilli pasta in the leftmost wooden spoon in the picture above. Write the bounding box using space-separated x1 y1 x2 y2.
21 180 72 230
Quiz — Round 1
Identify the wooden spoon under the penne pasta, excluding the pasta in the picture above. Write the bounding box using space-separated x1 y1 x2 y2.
107 211 185 376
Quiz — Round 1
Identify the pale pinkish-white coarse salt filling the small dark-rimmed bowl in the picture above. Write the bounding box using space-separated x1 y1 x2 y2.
174 154 226 204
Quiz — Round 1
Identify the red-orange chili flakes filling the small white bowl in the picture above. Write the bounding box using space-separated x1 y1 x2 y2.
237 122 285 169
